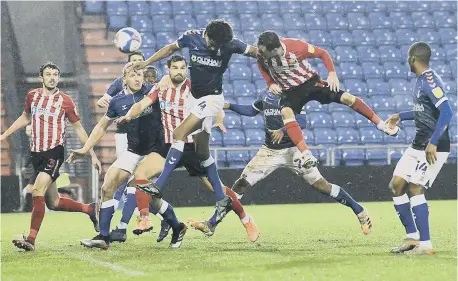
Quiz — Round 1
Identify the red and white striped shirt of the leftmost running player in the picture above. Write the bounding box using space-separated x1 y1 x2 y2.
24 88 80 152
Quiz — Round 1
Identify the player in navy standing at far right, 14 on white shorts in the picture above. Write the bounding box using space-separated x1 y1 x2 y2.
386 42 453 255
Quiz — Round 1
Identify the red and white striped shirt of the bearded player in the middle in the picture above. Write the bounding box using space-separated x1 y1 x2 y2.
148 79 193 143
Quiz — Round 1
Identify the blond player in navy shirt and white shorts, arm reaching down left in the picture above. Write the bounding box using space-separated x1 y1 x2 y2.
67 63 187 249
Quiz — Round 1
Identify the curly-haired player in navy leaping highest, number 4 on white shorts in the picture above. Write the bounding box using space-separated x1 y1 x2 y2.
137 20 257 222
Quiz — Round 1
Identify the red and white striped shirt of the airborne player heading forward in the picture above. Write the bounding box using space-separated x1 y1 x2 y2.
258 38 334 90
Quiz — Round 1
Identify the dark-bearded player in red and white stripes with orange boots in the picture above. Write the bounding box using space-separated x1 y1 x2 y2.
118 56 259 242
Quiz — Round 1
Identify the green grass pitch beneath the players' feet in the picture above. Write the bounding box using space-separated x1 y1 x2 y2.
1 201 457 281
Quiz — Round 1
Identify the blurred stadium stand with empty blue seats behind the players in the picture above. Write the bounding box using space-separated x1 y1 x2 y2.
1 1 457 212
